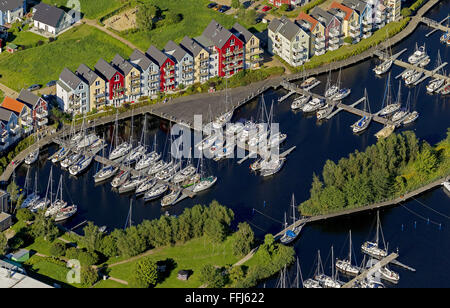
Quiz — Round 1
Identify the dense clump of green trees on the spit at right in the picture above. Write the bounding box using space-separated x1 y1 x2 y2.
300 131 450 215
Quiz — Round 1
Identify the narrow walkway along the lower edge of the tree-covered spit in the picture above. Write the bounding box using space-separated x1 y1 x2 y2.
275 175 450 238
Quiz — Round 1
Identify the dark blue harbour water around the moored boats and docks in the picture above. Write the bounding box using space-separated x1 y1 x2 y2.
12 0 450 287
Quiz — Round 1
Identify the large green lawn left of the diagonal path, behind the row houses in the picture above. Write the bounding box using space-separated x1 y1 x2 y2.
0 25 132 91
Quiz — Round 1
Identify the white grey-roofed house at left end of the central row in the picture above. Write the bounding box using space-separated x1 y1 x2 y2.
56 68 90 114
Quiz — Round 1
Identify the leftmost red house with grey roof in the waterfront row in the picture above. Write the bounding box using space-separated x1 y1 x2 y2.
95 59 126 107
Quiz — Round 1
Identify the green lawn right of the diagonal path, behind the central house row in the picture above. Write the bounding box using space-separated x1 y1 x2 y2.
118 0 264 50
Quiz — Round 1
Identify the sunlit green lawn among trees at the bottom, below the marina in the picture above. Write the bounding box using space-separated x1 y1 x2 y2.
109 236 239 288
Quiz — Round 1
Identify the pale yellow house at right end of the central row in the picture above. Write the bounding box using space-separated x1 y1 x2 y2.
230 23 264 69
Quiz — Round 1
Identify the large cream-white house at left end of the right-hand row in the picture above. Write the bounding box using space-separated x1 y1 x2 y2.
268 17 311 66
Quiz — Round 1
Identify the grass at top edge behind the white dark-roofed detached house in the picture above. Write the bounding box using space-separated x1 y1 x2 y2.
42 0 121 19
